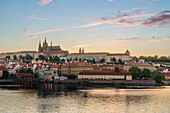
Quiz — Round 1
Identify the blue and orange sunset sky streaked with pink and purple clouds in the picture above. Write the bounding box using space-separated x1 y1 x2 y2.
0 0 170 56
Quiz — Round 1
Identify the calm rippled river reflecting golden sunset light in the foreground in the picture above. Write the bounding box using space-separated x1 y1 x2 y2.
0 84 170 113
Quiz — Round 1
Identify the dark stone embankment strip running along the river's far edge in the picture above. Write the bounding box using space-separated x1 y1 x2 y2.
0 79 161 86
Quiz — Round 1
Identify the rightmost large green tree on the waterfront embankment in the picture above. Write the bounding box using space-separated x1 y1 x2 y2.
152 70 165 83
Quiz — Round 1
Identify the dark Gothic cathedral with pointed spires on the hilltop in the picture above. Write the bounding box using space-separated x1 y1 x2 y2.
38 37 61 52
